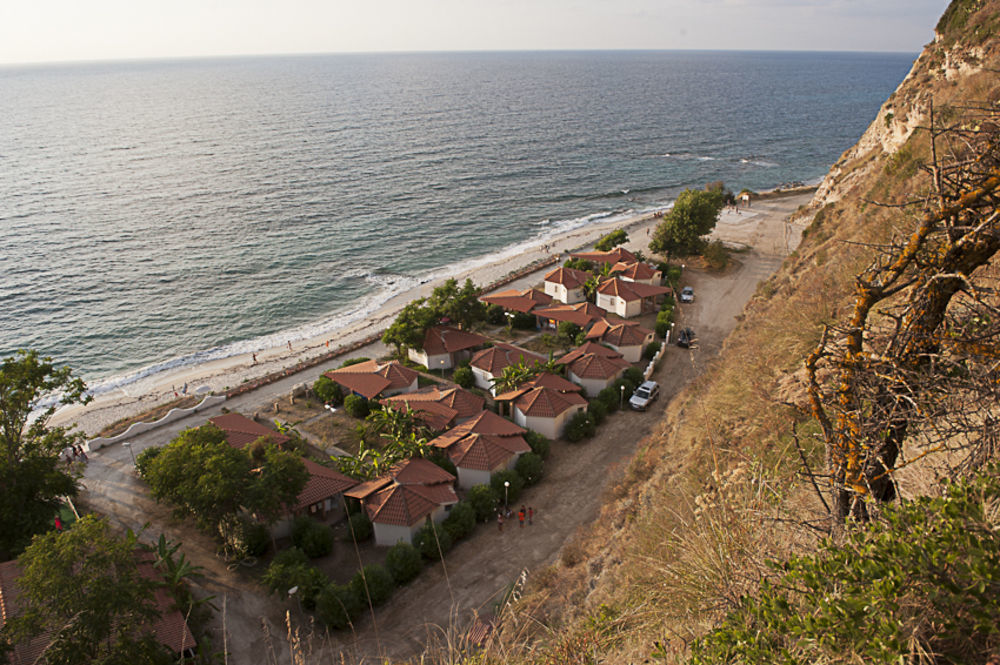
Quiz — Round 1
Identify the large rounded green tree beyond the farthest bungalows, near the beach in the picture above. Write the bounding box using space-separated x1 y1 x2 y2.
649 189 725 256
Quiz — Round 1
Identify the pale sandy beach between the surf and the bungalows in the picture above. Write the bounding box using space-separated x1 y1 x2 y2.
52 212 672 436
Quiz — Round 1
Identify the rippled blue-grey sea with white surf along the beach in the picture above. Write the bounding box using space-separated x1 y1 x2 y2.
0 51 917 392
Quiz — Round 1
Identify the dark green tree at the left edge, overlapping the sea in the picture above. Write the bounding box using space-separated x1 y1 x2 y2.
0 351 90 560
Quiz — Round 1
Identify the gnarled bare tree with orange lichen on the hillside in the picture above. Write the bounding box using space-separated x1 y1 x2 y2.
806 104 1000 528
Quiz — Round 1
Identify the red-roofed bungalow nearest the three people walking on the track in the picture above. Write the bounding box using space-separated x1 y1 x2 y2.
344 458 458 546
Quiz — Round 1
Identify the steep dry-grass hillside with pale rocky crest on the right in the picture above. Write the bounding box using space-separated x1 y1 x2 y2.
474 0 1000 663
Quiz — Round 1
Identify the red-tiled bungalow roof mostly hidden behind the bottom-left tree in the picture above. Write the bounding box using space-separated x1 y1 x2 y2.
0 551 196 665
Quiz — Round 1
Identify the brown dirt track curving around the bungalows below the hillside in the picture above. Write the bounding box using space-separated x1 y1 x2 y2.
78 189 810 665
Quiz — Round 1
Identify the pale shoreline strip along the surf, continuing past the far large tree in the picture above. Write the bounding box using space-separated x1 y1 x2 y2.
52 186 815 438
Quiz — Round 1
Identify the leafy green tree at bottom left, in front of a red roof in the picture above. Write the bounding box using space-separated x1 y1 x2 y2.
2 515 170 665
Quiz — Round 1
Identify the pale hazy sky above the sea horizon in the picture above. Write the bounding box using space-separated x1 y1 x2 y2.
0 0 948 63
